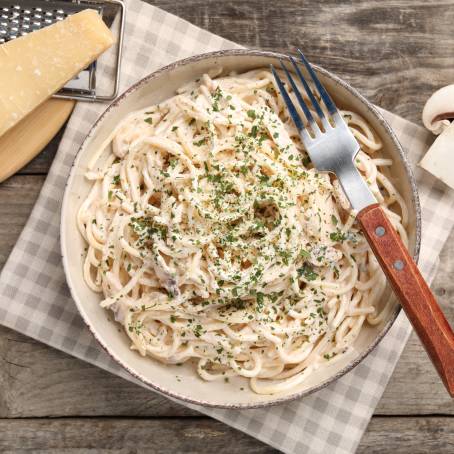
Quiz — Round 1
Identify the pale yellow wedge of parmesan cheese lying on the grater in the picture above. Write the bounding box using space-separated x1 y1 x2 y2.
0 9 114 136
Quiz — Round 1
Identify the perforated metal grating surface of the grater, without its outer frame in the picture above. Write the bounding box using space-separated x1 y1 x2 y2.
0 0 103 96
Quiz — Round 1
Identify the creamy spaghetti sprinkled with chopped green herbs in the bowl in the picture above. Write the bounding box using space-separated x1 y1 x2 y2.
77 69 408 394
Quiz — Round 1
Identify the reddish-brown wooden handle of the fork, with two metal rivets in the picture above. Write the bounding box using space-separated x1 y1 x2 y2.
357 204 454 397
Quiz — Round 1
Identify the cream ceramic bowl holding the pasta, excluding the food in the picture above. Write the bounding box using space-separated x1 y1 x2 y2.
61 50 421 408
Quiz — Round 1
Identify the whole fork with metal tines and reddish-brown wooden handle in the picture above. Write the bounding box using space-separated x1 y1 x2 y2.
271 49 454 397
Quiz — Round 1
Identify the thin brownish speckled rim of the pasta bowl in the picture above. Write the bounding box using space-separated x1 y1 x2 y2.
60 49 421 410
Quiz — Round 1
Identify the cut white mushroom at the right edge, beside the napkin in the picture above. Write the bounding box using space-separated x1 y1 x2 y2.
419 85 454 189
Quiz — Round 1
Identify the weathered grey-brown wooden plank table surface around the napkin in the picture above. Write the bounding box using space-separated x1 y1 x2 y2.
0 0 454 454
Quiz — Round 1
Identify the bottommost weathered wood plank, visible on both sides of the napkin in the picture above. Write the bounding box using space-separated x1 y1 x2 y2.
0 417 454 454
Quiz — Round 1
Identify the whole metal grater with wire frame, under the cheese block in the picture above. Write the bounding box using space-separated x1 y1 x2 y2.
0 0 125 101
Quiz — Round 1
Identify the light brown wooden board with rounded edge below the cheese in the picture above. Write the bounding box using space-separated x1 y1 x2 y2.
0 98 76 182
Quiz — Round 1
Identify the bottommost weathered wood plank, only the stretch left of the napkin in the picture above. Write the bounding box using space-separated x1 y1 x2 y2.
0 418 277 454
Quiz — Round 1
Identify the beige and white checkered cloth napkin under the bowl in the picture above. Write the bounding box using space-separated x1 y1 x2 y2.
0 0 454 454
